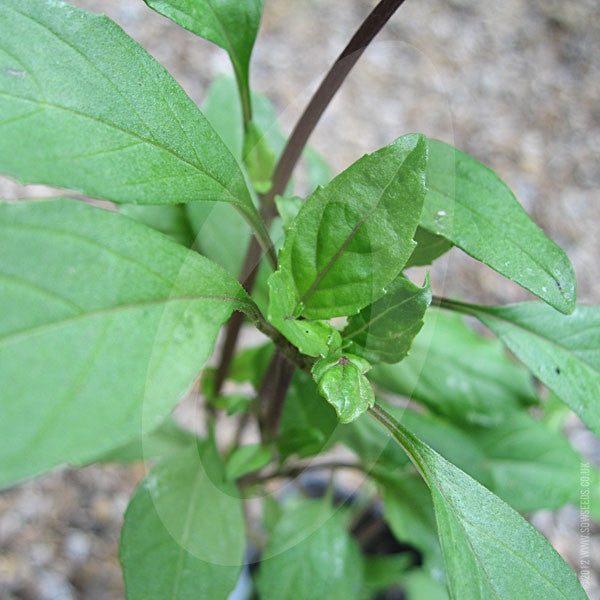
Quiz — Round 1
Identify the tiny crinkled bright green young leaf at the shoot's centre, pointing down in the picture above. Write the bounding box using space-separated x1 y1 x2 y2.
312 354 375 423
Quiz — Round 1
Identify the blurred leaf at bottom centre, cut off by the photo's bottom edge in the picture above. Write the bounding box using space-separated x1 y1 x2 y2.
257 500 363 600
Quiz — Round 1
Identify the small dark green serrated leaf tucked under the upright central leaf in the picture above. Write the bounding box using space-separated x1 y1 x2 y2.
342 276 431 363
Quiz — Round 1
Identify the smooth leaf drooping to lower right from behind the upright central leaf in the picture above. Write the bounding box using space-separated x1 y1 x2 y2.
421 140 575 314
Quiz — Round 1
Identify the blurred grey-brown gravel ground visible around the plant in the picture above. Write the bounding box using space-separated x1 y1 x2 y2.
0 0 600 600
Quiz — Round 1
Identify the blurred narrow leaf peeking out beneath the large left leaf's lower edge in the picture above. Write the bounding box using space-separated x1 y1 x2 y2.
84 418 199 463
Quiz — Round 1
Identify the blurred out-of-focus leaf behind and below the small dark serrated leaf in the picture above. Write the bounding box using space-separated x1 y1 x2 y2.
369 309 537 426
